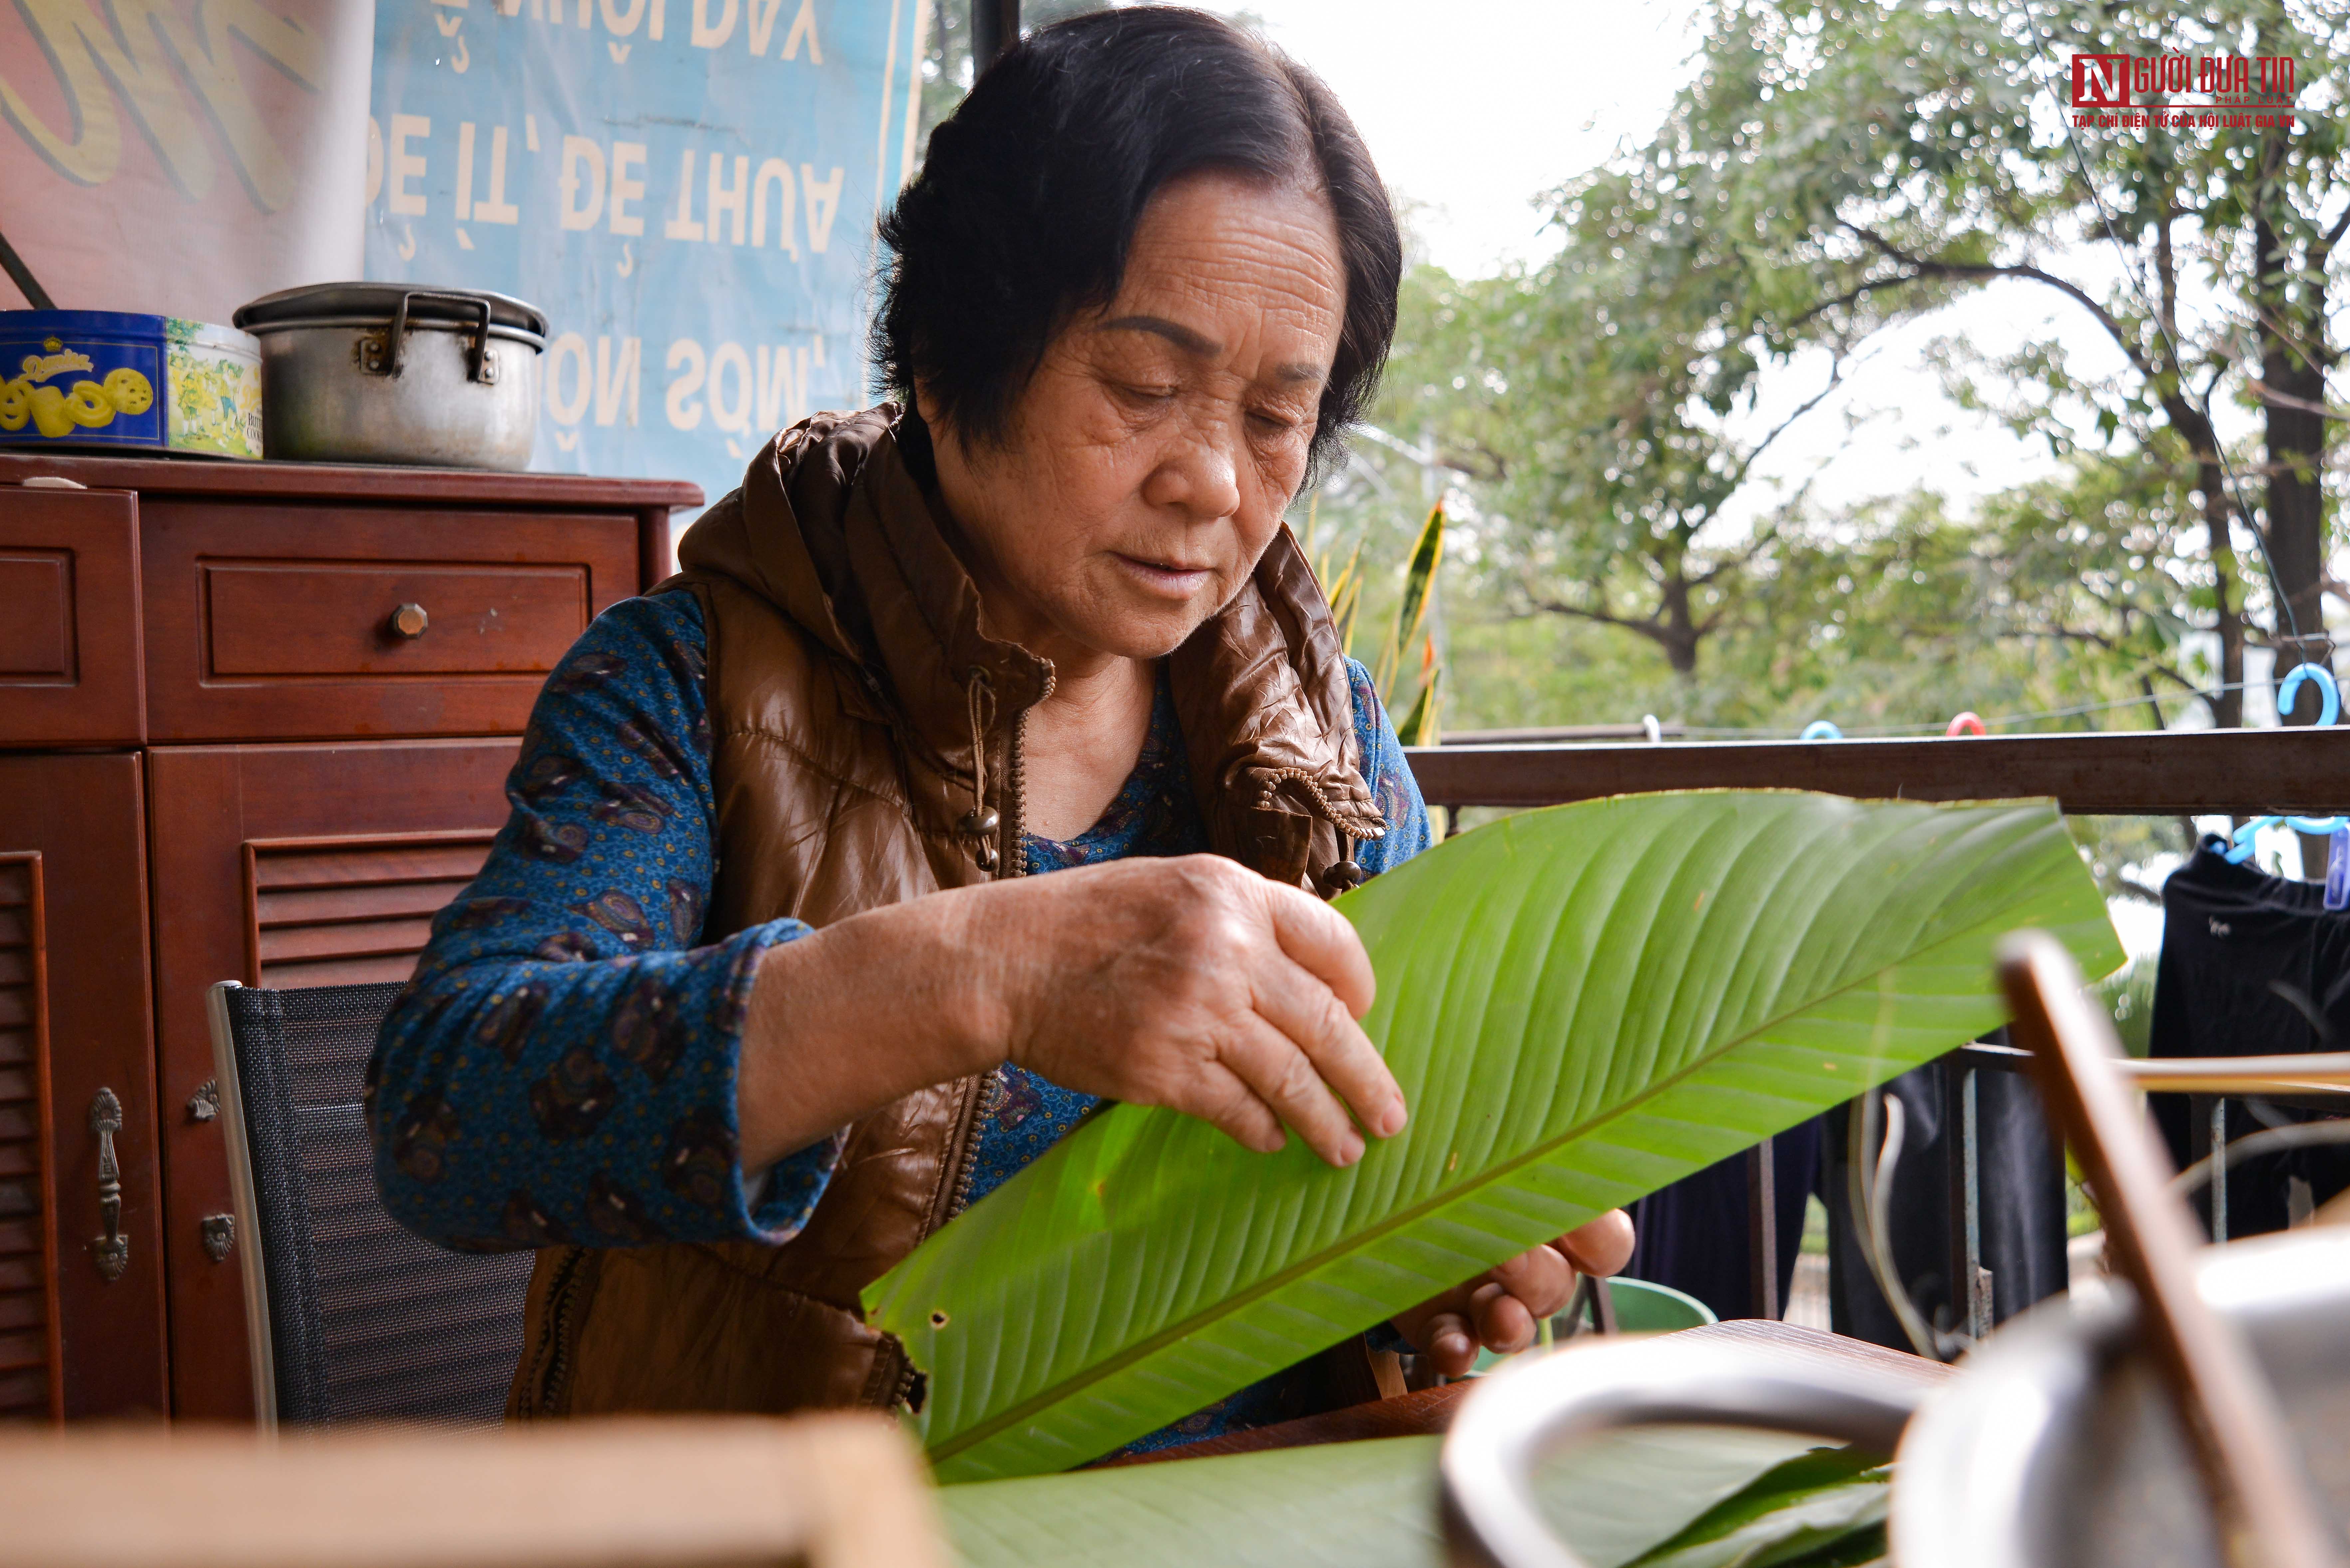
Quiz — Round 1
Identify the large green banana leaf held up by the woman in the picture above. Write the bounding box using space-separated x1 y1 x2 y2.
865 790 2122 1481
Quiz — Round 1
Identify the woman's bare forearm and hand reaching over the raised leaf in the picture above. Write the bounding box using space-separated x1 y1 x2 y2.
736 856 1405 1171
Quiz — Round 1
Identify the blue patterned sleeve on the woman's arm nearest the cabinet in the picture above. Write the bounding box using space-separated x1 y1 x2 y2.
366 592 836 1251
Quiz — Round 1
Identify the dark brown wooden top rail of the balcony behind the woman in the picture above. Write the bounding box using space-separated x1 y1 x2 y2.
1405 729 2350 816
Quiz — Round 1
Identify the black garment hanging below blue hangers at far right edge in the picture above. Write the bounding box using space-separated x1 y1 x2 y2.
2148 837 2350 1237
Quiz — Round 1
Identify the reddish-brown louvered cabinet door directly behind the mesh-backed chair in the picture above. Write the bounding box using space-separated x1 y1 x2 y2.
148 738 519 1420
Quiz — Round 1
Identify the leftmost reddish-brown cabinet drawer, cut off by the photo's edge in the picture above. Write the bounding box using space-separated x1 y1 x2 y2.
0 487 146 748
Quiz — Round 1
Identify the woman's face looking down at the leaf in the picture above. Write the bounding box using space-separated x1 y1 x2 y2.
921 172 1346 658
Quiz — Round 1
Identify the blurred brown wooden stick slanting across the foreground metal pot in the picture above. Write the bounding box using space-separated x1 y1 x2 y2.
2000 931 2341 1568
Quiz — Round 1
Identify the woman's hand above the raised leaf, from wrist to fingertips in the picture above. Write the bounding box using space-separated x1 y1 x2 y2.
973 856 1405 1166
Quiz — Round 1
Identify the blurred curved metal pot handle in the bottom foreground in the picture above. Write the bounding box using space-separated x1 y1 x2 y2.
1438 1335 1932 1568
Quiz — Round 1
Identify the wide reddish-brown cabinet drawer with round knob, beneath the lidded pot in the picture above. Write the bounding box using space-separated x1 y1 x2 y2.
139 501 639 740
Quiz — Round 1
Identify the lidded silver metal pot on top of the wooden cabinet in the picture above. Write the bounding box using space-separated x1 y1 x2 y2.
235 282 548 470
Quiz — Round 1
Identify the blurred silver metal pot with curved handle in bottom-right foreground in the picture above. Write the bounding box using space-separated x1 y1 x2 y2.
1443 1230 2350 1568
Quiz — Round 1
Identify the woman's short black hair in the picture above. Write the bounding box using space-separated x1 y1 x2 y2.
872 7 1403 475
